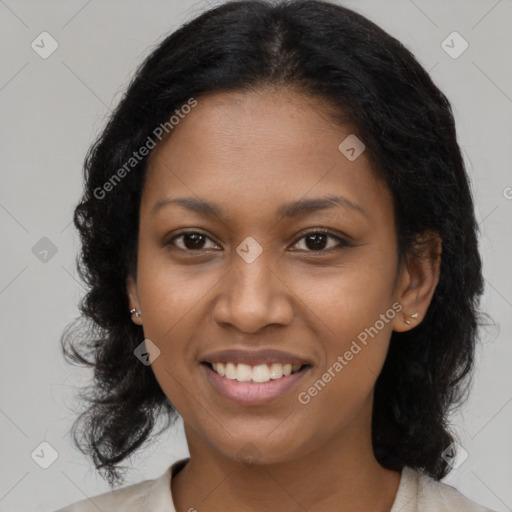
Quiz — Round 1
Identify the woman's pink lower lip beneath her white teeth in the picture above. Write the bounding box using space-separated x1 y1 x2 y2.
201 364 311 405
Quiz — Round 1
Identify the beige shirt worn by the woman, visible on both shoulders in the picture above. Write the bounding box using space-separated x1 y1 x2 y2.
56 458 494 512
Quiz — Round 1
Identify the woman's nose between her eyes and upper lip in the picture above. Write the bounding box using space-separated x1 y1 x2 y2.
213 250 294 333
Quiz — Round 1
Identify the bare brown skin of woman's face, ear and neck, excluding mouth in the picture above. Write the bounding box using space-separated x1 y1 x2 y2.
127 89 440 512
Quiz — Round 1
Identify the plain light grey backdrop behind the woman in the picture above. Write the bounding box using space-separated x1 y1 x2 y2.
0 0 512 512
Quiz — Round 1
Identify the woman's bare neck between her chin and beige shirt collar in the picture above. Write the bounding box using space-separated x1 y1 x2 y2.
172 398 400 512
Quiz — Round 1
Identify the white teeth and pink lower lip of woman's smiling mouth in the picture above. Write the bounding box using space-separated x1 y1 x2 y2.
200 361 311 405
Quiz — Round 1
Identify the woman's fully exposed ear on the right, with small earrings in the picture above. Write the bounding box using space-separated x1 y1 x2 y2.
393 231 442 332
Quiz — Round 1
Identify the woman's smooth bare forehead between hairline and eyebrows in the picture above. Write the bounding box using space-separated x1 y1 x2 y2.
142 89 391 226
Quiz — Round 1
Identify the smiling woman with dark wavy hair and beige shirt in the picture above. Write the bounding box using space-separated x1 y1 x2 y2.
55 0 496 512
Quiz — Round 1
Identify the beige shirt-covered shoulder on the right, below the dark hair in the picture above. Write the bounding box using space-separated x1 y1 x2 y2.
404 467 494 512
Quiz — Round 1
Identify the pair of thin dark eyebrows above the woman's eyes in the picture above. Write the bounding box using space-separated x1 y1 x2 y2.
150 196 369 218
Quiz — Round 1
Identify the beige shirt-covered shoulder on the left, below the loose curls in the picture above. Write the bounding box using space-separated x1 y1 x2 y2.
56 468 173 512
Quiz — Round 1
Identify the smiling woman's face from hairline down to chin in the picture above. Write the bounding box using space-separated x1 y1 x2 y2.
128 90 424 463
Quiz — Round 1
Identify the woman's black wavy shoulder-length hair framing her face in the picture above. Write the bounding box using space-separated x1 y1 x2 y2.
61 0 483 486
